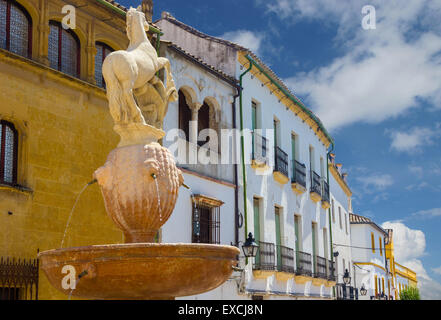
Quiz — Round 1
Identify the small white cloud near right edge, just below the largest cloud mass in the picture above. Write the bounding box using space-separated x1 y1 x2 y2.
390 127 439 153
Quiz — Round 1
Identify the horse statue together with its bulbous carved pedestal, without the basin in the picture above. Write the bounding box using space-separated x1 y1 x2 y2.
94 8 184 243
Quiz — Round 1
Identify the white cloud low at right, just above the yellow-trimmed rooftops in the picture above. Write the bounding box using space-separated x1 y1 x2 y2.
381 221 441 299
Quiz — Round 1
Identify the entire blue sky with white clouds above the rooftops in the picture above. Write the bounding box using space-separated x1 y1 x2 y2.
120 0 441 299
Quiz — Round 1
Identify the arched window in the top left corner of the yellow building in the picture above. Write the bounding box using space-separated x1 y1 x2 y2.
0 0 32 58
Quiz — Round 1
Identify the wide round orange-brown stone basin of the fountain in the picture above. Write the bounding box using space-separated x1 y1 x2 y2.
38 243 240 300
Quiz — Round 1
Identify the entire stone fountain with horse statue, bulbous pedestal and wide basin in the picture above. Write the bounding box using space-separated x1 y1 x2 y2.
39 8 239 299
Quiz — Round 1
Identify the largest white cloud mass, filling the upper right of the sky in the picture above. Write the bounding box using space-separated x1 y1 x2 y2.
260 0 441 130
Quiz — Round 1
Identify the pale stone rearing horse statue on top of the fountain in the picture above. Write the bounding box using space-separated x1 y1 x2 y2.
103 8 178 126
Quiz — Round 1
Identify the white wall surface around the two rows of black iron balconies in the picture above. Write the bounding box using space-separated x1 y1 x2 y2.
237 60 331 296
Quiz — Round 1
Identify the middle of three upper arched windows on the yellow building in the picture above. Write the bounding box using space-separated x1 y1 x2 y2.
48 21 80 77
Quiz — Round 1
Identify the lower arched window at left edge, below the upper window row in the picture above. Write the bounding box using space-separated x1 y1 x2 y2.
0 120 18 185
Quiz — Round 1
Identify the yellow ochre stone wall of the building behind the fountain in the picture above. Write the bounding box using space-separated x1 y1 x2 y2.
0 0 132 299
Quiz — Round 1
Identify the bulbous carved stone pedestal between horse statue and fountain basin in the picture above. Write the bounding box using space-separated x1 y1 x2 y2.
95 142 184 243
